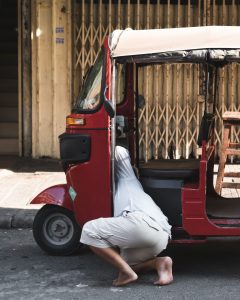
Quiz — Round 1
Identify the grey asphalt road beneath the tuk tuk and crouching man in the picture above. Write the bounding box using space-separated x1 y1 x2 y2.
0 229 240 300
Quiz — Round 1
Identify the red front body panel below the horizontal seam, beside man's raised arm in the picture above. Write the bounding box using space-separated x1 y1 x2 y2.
67 130 112 225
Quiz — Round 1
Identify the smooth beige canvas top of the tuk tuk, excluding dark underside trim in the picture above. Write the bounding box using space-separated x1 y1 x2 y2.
109 26 240 58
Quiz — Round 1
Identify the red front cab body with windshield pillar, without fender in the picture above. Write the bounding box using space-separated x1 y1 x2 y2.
66 42 112 226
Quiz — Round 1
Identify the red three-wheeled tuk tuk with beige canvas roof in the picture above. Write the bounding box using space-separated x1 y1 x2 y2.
31 26 240 255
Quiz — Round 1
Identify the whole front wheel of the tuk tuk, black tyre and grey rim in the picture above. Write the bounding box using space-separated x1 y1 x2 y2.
33 205 81 255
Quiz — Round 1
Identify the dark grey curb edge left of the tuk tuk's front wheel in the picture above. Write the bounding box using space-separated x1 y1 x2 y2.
0 208 38 229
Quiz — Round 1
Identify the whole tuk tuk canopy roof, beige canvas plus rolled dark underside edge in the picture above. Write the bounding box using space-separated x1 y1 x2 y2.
109 26 240 63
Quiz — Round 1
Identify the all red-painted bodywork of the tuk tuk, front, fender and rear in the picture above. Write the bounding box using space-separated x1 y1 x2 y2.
31 38 240 239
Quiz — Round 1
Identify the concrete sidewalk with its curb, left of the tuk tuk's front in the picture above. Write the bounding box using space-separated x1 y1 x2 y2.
0 156 66 228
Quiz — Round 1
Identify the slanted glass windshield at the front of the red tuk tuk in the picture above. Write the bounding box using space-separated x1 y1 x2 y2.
74 49 104 112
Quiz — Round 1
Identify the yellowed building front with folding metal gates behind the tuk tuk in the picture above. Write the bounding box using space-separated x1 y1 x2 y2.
0 0 240 158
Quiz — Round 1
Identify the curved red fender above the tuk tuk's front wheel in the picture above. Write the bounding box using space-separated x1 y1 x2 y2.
31 184 73 211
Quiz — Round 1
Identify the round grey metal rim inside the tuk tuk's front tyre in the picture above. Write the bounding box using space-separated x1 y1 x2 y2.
43 213 74 246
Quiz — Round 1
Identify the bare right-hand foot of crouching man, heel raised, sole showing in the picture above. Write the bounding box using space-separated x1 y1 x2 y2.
154 256 173 285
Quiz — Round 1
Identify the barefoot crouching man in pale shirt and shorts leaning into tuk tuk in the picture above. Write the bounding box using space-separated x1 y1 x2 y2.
80 146 173 286
